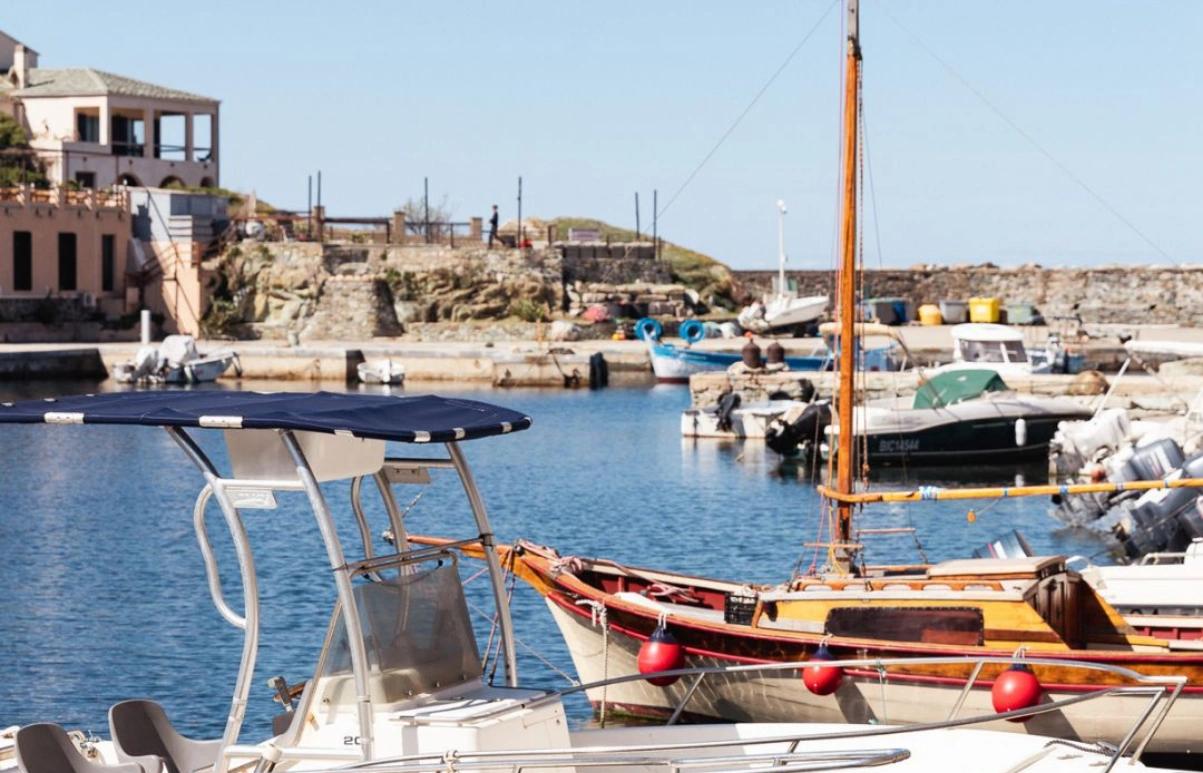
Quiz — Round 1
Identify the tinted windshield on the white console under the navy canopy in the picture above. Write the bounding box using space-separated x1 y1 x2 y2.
322 560 481 704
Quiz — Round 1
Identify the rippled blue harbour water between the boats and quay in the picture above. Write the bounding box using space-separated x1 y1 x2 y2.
0 382 1103 739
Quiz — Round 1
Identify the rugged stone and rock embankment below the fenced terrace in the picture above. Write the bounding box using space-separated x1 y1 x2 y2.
205 243 697 340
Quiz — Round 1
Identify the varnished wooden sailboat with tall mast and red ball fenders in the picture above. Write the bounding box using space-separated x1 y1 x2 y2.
416 0 1203 753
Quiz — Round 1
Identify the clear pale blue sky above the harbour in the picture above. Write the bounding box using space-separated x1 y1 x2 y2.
11 0 1203 268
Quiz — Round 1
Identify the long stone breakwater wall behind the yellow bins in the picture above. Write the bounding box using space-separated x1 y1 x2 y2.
734 266 1203 326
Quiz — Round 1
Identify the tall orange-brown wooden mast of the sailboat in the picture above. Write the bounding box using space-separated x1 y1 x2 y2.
834 0 860 566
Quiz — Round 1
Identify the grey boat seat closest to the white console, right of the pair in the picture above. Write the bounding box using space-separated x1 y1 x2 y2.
108 701 221 773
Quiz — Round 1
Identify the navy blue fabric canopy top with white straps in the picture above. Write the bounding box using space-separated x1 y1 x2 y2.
0 390 531 442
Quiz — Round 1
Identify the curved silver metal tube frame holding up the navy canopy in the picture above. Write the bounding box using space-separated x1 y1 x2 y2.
165 427 517 761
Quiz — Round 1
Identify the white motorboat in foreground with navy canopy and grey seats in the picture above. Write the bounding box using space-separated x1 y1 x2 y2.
0 391 1183 773
